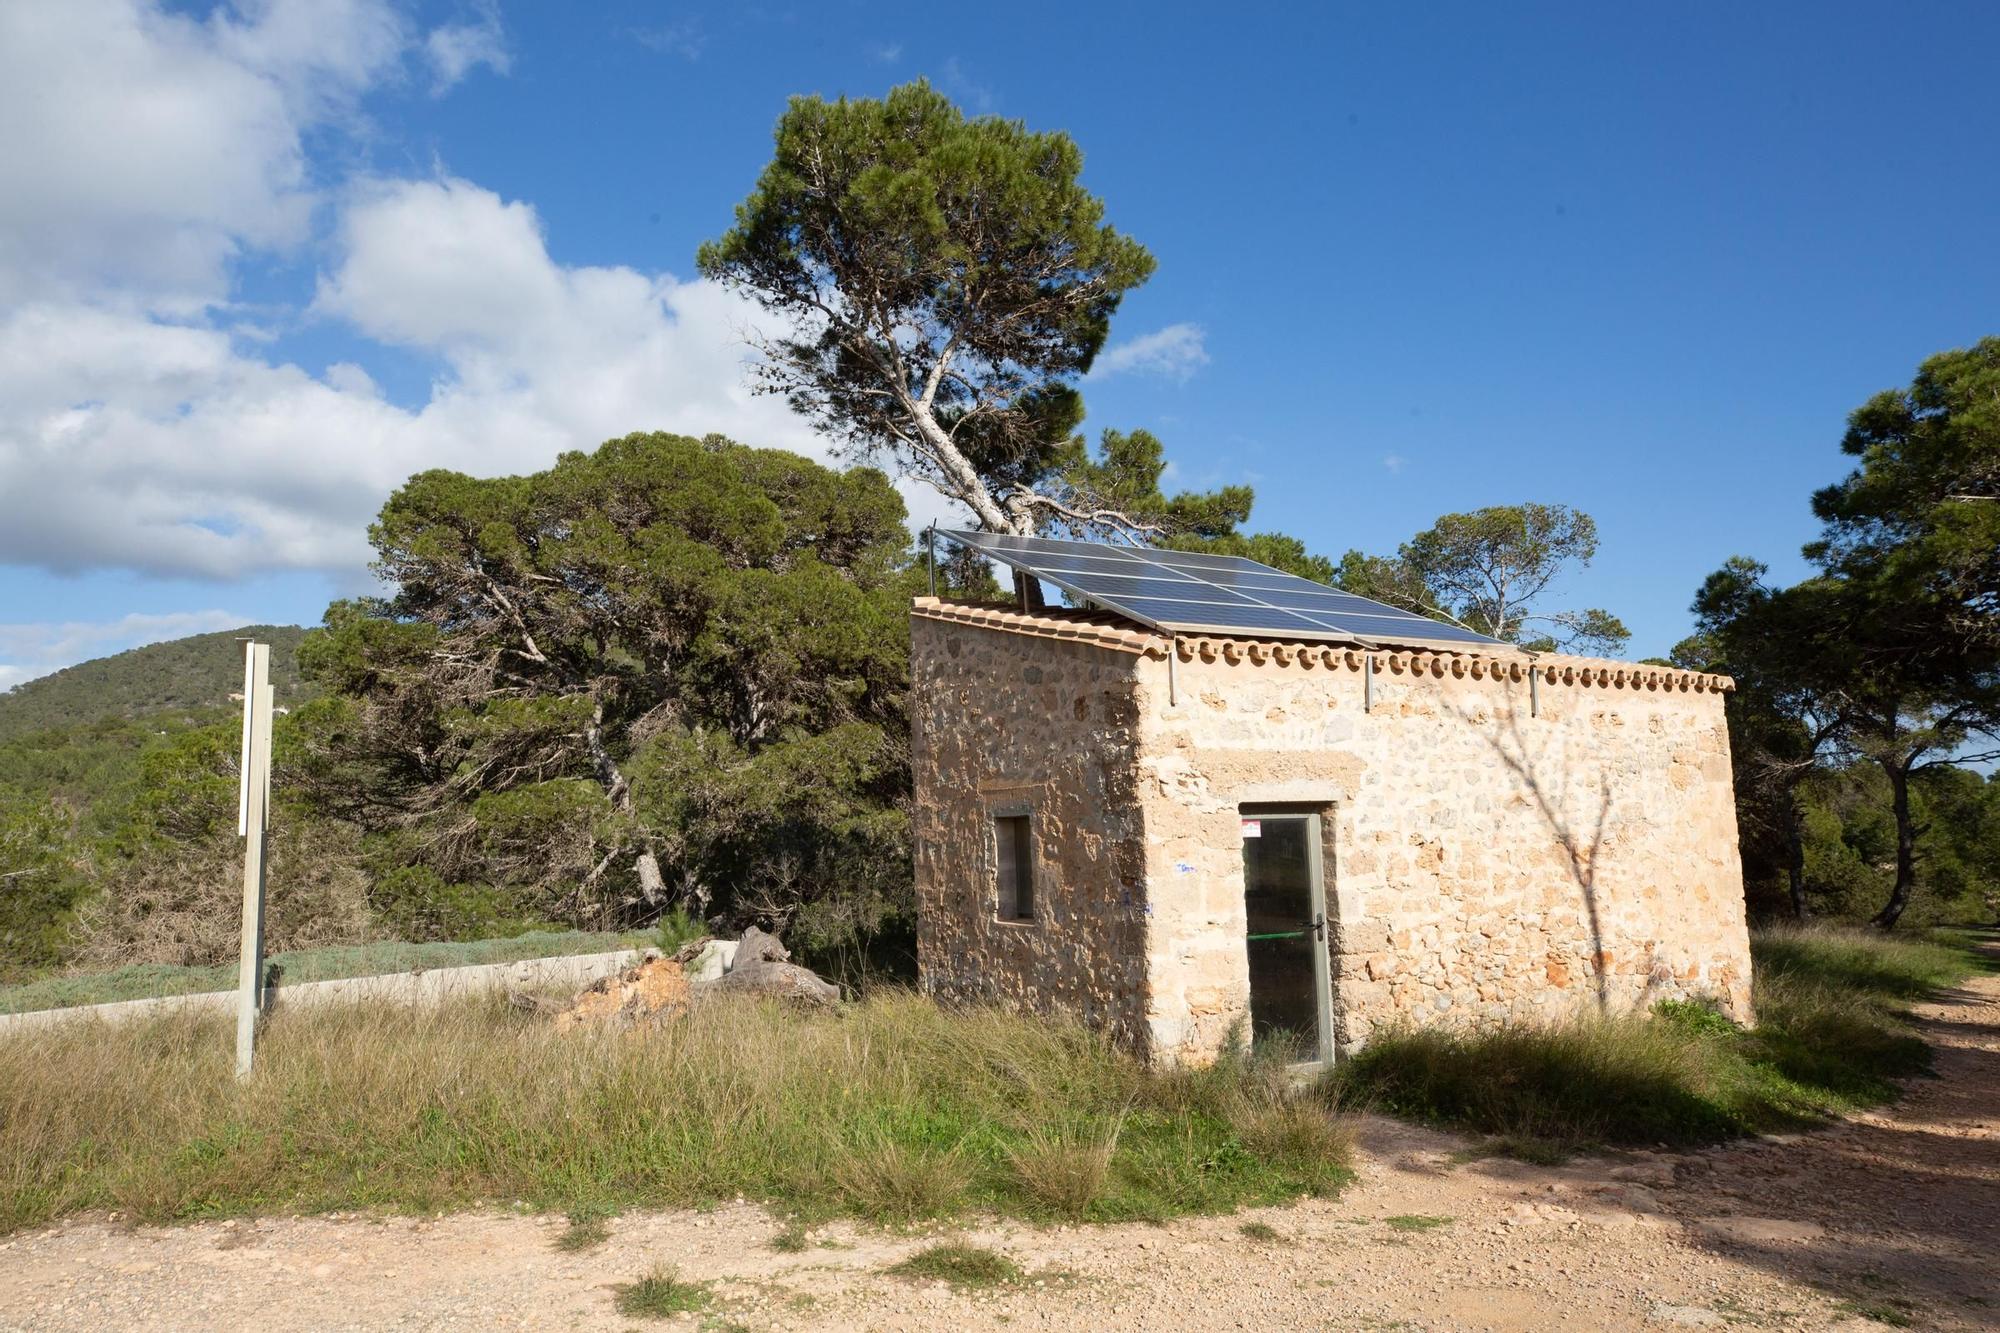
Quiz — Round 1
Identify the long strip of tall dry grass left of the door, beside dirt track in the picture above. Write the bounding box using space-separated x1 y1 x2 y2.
0 980 1348 1231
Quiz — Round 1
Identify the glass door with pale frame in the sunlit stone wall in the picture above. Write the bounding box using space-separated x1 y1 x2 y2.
1242 811 1332 1063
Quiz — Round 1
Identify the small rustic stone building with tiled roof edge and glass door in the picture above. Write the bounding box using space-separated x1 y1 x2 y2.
910 598 1750 1061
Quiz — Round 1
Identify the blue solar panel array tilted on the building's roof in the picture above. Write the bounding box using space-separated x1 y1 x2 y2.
944 532 1508 648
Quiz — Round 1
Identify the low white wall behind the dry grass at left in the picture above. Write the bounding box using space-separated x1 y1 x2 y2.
0 949 642 1037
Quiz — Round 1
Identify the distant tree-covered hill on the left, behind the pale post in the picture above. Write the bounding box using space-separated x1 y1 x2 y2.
0 624 310 741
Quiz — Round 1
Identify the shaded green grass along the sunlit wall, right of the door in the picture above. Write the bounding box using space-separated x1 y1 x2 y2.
1334 927 1990 1157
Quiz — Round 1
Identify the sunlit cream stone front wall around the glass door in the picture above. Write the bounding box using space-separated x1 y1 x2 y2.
1138 638 1750 1057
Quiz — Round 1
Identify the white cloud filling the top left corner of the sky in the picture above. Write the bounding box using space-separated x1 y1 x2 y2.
0 0 404 312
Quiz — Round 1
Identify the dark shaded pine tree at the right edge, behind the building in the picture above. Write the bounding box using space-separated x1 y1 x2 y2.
1684 338 2000 927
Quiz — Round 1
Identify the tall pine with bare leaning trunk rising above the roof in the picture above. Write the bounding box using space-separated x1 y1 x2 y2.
698 80 1154 532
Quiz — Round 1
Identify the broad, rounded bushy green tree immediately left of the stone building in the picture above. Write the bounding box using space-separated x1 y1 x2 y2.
300 434 912 944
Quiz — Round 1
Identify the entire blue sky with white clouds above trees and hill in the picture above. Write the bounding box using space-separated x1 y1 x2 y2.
0 0 2000 687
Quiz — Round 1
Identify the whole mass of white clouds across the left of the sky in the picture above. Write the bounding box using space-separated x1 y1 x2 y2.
0 0 930 592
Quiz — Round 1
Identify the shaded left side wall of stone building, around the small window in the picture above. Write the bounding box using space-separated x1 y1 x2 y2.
910 614 1146 1049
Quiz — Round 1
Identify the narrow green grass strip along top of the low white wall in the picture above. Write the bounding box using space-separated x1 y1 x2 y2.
0 931 654 1013
